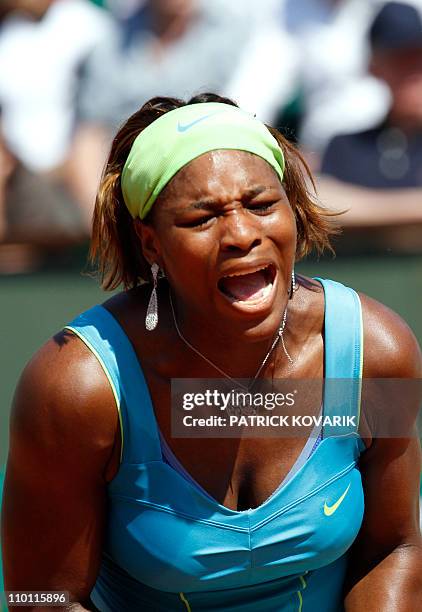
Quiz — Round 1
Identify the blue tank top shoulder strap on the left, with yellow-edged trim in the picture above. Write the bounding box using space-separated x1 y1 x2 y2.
65 305 162 463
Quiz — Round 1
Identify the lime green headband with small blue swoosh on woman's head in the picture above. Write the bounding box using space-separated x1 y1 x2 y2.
121 102 284 219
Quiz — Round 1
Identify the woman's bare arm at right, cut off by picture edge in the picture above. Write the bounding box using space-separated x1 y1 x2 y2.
345 298 422 612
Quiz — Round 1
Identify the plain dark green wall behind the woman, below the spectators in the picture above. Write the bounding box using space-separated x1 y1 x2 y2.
0 251 422 609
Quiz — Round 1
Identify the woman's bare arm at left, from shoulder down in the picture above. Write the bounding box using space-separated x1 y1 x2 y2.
2 333 117 612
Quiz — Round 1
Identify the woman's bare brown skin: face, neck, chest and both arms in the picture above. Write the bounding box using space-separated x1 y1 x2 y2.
2 151 422 612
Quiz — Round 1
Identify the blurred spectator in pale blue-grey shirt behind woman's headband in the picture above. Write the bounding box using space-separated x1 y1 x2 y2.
69 0 253 220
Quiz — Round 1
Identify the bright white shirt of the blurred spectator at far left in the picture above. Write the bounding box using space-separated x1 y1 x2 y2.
0 0 108 172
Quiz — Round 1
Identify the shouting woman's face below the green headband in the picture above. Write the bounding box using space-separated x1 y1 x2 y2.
142 150 296 335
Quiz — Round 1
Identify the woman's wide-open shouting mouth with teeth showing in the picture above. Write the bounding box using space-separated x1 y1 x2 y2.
218 264 276 304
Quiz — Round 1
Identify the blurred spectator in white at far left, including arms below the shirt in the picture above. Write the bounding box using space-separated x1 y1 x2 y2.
0 0 110 240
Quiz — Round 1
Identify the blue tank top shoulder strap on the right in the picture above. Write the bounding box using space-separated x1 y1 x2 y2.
315 278 363 437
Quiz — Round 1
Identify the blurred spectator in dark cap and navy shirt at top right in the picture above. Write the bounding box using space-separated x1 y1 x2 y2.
294 0 422 252
